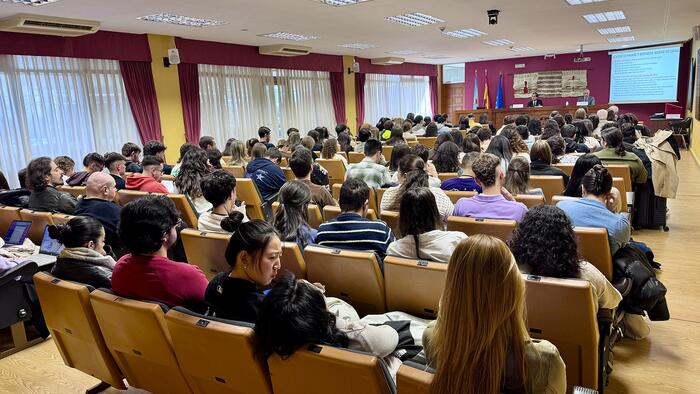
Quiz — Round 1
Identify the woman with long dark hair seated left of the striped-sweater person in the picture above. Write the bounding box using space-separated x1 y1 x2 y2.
272 181 316 250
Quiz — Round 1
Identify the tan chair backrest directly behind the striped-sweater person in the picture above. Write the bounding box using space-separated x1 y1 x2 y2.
304 246 386 315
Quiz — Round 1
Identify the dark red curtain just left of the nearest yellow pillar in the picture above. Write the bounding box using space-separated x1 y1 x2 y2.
119 61 163 143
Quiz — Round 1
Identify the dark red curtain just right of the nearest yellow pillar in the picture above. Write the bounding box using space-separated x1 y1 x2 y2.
177 63 201 144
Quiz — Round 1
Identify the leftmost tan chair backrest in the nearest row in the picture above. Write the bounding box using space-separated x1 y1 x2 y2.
34 272 126 390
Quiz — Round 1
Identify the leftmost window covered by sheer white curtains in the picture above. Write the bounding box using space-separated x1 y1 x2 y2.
0 56 140 187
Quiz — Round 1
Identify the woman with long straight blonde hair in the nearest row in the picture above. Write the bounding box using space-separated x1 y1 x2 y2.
423 234 566 394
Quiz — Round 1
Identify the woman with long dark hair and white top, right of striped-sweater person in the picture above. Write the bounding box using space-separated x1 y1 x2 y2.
387 187 467 263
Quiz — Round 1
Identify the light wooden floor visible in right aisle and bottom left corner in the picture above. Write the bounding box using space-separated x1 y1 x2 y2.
0 152 700 394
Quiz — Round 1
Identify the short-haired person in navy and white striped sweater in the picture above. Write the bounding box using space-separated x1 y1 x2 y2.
316 178 394 257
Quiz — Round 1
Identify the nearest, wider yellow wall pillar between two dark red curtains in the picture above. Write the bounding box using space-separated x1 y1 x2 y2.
148 34 185 163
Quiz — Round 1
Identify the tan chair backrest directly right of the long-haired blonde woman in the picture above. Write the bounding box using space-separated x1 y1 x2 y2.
523 275 605 389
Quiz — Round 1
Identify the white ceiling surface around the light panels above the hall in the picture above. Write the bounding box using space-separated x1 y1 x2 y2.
0 0 700 64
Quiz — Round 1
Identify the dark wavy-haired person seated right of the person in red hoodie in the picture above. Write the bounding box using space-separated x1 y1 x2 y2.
174 148 213 215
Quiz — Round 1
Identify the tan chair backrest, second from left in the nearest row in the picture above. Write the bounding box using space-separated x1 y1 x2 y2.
90 289 194 393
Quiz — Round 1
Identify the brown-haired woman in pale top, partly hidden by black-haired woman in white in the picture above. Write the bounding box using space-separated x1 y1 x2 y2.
379 155 454 224
